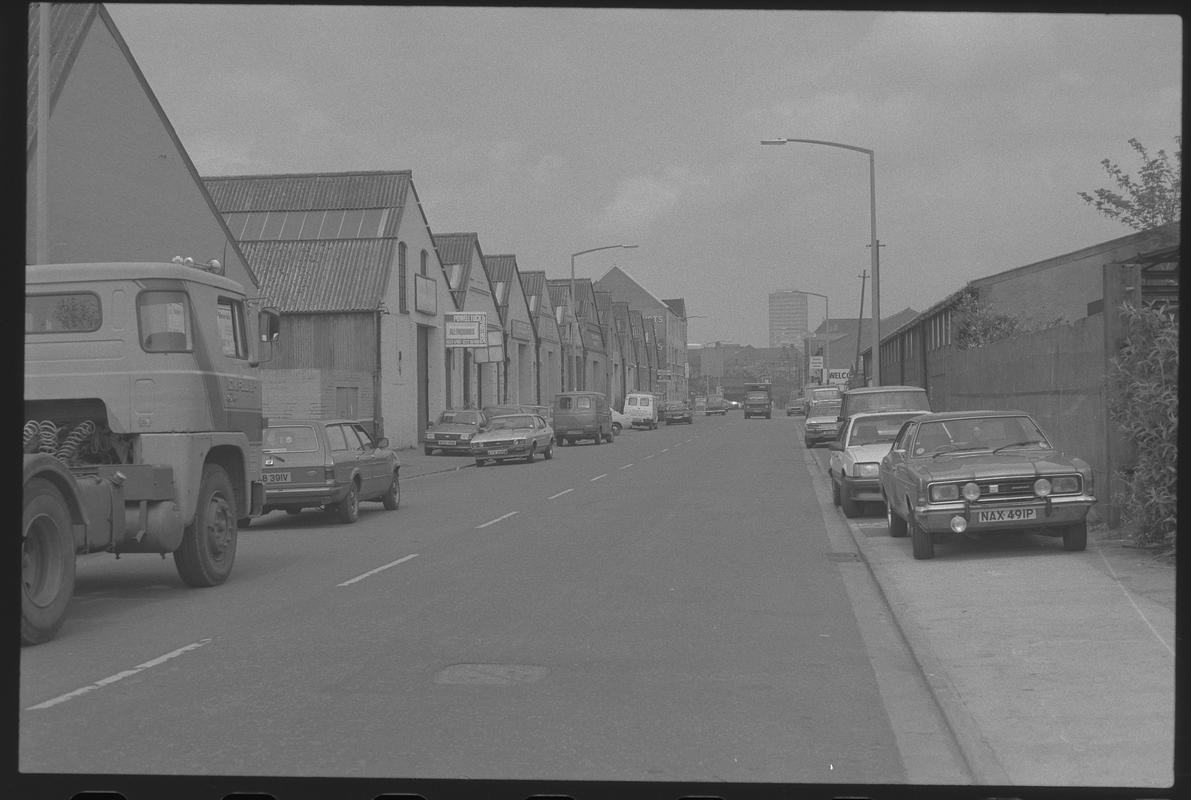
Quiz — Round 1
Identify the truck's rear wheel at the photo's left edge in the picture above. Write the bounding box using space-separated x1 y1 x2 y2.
20 477 75 644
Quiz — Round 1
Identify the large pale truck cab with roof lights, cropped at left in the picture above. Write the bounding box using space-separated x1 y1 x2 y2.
20 258 279 644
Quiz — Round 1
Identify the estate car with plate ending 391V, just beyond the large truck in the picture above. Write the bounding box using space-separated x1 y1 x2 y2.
262 419 401 523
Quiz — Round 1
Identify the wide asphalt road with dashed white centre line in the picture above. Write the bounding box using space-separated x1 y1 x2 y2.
19 415 967 783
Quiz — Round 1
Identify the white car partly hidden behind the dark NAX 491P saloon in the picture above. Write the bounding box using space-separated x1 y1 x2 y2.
827 411 918 518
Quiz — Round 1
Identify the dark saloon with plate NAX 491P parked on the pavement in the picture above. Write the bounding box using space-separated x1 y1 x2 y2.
879 411 1096 558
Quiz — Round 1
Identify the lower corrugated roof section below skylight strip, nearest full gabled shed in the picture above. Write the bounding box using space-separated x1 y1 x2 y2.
239 239 397 313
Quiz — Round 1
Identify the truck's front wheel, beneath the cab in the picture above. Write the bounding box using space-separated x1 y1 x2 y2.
174 464 237 587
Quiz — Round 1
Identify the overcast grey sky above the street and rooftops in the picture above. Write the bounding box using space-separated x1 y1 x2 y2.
107 5 1183 346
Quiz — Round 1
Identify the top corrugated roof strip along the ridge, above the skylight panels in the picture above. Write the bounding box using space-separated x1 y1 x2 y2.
202 170 412 223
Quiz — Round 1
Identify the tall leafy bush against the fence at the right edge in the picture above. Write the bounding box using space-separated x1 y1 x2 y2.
1109 302 1179 550
